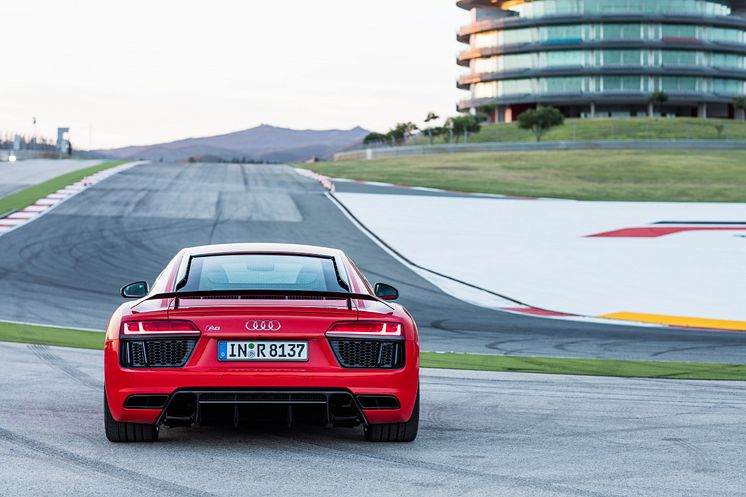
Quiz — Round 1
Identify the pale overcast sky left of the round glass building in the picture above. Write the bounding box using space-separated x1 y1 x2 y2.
0 0 468 149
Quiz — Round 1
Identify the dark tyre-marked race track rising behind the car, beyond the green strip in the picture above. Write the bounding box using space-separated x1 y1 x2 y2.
0 164 746 363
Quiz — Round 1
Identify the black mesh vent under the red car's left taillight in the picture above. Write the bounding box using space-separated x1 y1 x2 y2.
122 339 197 368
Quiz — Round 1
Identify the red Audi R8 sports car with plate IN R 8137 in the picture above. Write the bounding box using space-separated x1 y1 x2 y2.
104 243 419 442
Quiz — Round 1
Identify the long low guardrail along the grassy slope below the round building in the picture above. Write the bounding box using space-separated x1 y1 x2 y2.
334 140 746 161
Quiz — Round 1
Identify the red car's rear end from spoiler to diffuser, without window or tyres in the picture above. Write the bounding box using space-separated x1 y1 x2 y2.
105 246 419 439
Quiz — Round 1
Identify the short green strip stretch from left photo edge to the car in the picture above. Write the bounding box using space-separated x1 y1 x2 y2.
0 323 104 349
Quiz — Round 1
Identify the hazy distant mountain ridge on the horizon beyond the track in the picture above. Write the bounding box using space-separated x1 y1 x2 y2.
97 124 368 162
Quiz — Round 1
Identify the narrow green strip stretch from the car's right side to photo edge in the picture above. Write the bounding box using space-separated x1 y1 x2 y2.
420 352 746 380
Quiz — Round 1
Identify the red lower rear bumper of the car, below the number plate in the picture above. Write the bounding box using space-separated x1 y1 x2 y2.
104 340 419 424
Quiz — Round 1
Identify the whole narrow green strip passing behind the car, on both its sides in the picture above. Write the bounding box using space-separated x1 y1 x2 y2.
0 322 746 380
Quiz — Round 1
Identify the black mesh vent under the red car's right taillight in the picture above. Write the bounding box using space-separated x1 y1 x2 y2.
329 339 404 369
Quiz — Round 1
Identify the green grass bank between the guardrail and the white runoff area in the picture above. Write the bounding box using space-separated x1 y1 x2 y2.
299 150 746 202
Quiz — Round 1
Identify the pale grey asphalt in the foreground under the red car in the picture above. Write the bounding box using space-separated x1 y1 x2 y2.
0 343 746 497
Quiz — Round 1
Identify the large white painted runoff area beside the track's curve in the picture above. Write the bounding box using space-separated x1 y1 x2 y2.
335 193 746 320
